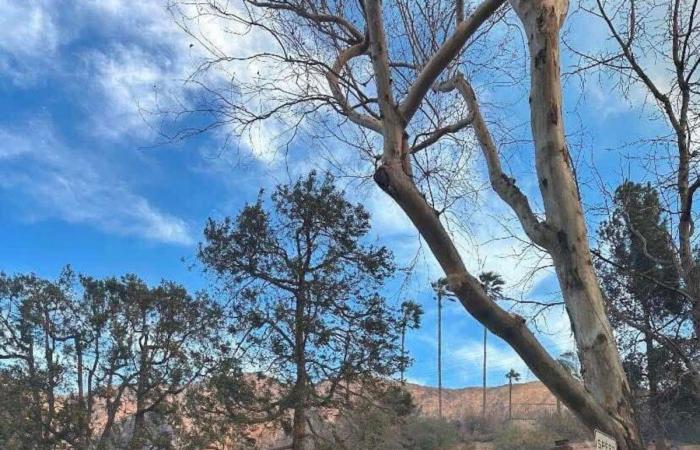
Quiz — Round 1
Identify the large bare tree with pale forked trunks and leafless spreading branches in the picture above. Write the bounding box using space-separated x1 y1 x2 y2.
167 0 642 449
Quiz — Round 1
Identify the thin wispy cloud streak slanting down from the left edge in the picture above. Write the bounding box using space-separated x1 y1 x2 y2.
0 123 193 245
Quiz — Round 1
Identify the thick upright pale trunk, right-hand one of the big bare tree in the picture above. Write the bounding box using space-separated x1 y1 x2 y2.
511 0 642 449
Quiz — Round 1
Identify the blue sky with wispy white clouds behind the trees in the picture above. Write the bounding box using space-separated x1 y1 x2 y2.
0 0 668 387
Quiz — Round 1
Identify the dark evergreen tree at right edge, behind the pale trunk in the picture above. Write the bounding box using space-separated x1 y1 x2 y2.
598 181 700 436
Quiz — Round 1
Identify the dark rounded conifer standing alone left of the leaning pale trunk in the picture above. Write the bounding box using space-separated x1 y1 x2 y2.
199 172 404 450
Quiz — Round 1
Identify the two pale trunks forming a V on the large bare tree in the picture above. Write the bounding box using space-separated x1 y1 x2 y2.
365 0 643 450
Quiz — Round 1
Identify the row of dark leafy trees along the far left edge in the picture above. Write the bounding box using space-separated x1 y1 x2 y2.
0 269 222 450
